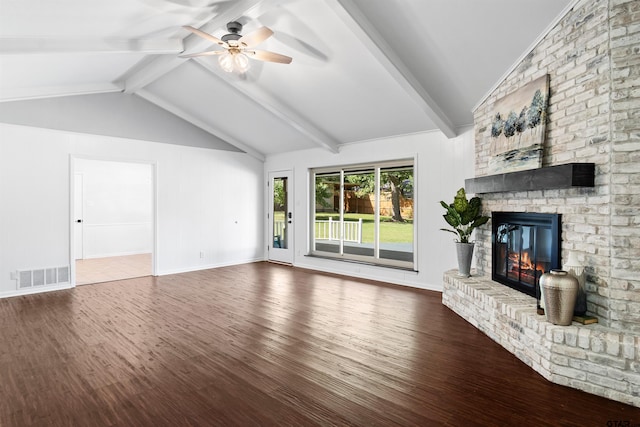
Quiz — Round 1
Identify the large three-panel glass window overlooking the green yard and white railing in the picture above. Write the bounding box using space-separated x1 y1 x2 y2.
311 160 415 269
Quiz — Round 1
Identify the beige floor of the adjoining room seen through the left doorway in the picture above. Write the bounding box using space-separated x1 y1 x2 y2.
76 254 152 285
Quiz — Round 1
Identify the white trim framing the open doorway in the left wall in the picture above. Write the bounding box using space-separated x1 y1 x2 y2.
69 154 158 287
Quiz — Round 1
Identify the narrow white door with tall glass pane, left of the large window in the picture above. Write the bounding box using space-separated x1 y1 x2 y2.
267 171 295 264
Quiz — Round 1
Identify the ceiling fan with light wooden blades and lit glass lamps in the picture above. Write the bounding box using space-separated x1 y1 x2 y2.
180 21 292 73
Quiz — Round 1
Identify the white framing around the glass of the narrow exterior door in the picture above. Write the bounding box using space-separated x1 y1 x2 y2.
266 169 297 265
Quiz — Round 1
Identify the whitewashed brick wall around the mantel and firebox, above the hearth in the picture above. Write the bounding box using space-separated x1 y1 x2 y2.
474 0 640 332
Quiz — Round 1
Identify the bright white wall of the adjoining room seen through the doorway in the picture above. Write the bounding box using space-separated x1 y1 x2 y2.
73 159 154 258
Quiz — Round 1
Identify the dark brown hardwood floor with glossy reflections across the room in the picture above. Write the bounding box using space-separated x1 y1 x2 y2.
0 263 640 427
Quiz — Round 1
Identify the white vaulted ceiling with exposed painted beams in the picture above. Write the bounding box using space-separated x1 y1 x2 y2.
0 0 572 157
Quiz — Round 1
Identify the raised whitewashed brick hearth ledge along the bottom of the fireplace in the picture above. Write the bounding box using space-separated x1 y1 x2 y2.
442 270 640 407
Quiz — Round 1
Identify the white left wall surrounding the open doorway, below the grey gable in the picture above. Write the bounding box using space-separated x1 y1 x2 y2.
0 124 265 296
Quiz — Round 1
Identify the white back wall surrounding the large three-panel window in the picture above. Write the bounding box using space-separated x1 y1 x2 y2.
265 129 475 290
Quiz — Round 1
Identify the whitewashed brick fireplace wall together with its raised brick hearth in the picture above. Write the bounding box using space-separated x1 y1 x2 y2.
443 0 640 407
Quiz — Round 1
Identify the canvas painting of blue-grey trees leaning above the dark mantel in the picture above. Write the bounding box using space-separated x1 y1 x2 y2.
489 75 549 173
